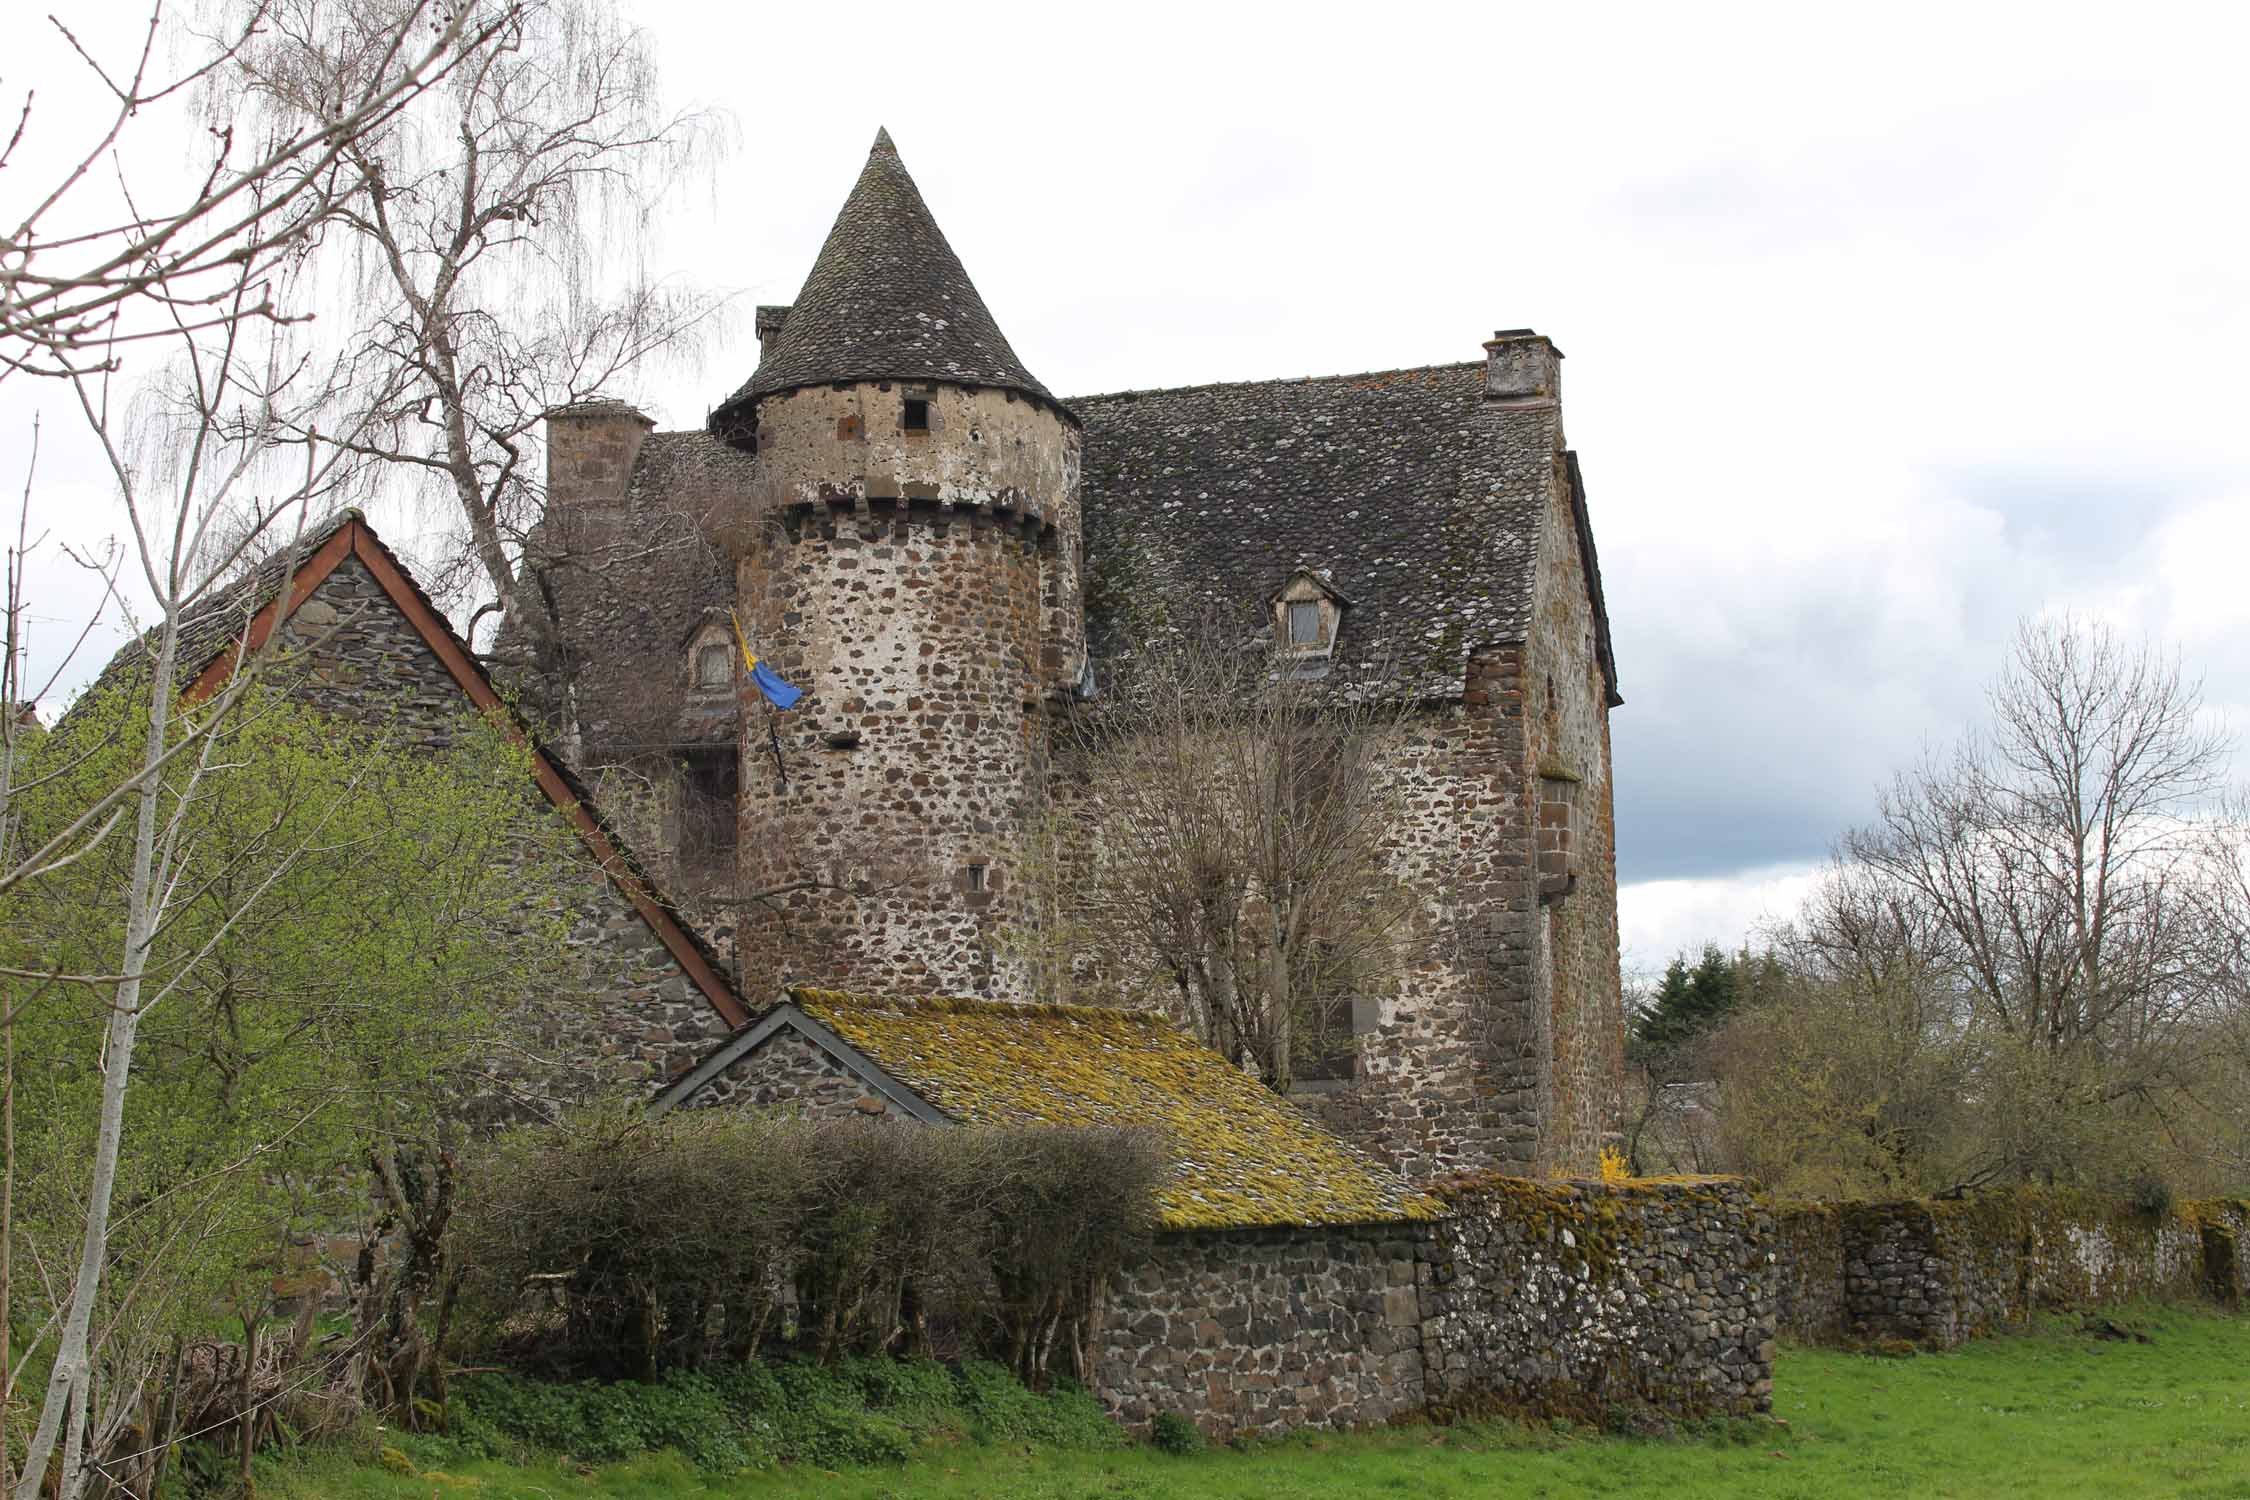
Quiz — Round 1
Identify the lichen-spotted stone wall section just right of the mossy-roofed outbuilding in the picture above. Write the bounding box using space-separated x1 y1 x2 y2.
1422 1178 1775 1419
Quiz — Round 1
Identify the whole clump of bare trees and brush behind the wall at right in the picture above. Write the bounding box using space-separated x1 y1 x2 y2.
1717 618 2243 1192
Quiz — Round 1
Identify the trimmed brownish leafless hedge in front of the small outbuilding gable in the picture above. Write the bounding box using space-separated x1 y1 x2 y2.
452 1111 1163 1385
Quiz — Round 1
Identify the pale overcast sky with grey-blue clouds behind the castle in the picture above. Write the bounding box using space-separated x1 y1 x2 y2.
0 0 2250 967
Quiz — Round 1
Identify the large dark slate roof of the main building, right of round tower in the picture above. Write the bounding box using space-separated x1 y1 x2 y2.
1071 362 1546 695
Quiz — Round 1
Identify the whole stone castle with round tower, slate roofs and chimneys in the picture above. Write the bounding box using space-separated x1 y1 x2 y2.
497 135 1622 1178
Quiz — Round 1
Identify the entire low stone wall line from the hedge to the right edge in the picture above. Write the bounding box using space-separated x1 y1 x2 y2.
1094 1176 2250 1437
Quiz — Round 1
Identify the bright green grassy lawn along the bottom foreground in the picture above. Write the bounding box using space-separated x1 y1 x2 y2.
272 1309 2250 1500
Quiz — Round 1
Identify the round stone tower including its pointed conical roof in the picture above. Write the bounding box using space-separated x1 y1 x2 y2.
711 133 1085 1001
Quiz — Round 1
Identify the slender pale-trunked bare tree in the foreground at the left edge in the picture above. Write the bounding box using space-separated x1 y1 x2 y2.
0 2 515 1500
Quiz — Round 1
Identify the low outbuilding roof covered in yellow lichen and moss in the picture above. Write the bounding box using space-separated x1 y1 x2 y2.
790 990 1442 1230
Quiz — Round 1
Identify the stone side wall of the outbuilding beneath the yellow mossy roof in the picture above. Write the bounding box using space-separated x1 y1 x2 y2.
1094 1223 1424 1437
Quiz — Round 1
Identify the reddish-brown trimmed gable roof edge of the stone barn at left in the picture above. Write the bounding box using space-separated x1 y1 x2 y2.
97 510 749 1025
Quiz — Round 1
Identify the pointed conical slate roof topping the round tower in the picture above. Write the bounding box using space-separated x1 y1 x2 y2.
711 130 1055 432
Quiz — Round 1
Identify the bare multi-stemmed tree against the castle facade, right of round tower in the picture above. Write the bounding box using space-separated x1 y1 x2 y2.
1046 625 1418 1091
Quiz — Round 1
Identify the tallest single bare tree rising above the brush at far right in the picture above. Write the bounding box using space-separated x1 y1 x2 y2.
1845 618 2230 1061
